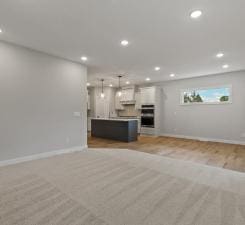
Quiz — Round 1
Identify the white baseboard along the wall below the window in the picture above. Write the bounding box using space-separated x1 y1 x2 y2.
161 133 245 145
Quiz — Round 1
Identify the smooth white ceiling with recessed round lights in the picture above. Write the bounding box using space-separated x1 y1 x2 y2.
0 0 245 84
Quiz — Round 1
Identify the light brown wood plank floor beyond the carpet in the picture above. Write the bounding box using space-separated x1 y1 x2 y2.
88 135 245 172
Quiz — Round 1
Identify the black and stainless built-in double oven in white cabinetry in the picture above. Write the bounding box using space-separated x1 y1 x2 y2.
141 105 155 128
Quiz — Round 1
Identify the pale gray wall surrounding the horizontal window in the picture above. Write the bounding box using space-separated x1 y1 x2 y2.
158 71 245 143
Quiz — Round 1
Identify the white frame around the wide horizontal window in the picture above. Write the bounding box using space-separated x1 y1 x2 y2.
180 85 233 106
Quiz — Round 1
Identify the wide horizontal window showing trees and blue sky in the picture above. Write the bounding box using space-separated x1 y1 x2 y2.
181 86 232 105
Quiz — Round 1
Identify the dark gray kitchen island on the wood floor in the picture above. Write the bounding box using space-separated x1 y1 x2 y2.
91 119 138 142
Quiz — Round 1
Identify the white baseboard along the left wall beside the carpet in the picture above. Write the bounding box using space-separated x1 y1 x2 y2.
0 145 88 167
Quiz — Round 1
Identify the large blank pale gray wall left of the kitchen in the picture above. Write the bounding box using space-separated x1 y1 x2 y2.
0 42 87 161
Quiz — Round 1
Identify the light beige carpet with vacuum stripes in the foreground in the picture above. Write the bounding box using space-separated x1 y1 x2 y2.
0 149 245 225
